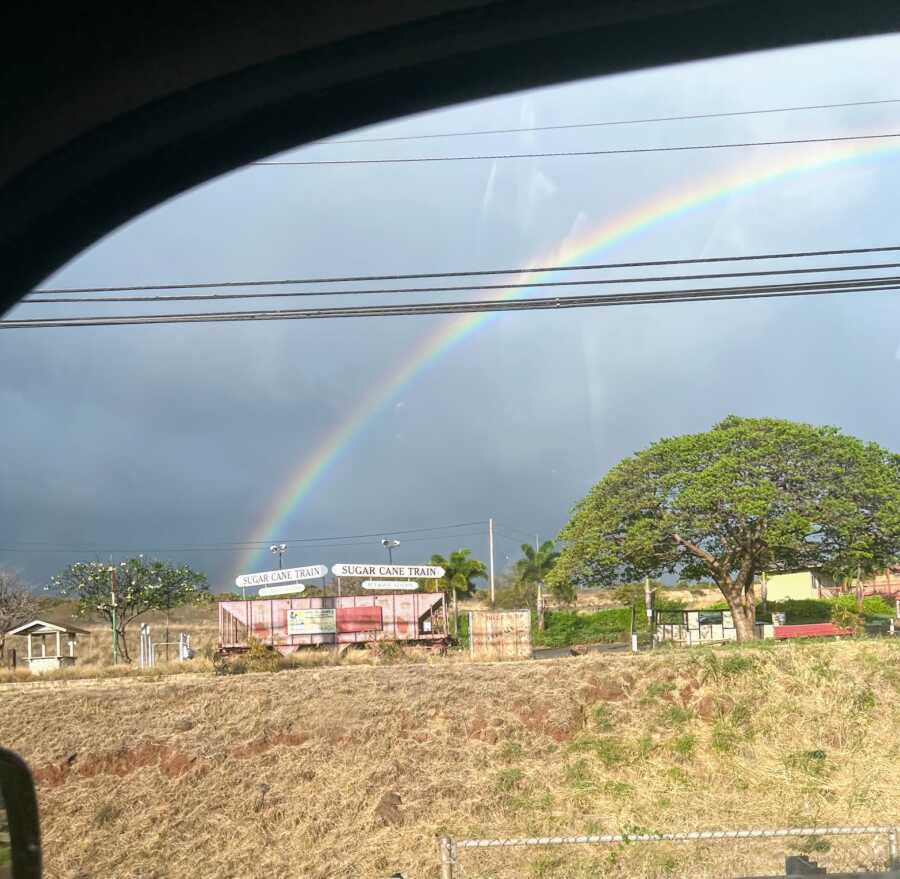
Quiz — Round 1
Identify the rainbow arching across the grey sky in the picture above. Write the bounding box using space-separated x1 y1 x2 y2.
238 134 900 572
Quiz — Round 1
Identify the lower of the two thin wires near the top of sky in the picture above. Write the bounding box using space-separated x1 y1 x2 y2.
245 132 900 168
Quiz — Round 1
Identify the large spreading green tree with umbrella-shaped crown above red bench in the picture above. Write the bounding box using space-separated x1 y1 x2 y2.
548 416 900 640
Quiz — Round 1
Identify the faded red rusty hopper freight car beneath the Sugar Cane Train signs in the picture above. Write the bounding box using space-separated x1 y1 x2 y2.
219 592 448 654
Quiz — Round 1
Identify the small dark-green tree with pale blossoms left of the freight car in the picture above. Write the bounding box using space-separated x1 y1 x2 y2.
52 556 209 662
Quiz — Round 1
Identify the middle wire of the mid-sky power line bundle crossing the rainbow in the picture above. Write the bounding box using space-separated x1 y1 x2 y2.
19 262 900 305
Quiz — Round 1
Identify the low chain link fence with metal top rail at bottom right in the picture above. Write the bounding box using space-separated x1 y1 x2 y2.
440 827 900 879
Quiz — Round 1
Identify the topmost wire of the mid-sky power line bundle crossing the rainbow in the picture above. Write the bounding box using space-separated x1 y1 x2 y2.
31 244 900 296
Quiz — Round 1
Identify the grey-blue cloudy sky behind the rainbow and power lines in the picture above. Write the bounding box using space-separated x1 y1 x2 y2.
0 38 900 588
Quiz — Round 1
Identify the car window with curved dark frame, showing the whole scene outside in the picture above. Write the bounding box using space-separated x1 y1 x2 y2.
0 37 900 879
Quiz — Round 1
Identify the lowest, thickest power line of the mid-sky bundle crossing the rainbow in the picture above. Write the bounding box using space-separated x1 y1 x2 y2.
0 276 900 330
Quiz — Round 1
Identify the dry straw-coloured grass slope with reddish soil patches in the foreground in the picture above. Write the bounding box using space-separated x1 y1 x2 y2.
0 640 900 879
